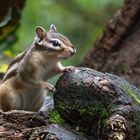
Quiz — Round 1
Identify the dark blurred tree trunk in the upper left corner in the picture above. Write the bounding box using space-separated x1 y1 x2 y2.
0 0 25 40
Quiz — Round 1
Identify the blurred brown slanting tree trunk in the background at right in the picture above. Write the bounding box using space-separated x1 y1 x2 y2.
80 0 140 87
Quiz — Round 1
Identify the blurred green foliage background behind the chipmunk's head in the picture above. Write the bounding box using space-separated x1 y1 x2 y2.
1 0 123 81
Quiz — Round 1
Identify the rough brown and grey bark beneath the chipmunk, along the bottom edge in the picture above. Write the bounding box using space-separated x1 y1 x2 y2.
0 111 87 140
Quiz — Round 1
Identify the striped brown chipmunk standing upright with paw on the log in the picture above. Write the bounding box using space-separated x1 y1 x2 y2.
0 25 76 111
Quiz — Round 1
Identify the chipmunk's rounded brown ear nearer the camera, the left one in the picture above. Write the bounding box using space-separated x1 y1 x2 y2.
35 26 46 39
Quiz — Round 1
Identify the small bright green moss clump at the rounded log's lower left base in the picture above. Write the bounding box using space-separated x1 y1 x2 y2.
49 110 65 124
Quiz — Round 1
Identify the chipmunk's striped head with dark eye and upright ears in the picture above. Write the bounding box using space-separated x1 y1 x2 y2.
35 25 76 59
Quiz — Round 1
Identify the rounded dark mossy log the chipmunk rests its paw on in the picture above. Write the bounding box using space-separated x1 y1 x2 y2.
54 68 140 140
